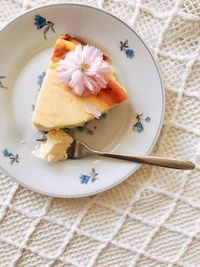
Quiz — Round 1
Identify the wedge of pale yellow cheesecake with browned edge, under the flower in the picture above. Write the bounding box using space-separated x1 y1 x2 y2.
32 35 128 131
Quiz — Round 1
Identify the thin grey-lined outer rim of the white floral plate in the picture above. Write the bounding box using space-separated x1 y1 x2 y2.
0 3 166 198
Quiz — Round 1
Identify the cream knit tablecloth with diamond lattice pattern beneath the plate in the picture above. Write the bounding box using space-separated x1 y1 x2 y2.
0 0 200 267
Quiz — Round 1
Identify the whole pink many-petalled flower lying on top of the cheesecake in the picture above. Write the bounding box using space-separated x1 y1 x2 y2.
57 44 110 96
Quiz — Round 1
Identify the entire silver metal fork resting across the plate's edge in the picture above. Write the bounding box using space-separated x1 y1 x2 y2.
67 140 195 170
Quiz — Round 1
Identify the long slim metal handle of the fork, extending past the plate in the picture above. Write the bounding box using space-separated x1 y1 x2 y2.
97 152 195 170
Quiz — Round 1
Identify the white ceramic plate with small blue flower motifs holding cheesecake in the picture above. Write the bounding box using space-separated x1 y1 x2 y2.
0 4 164 197
